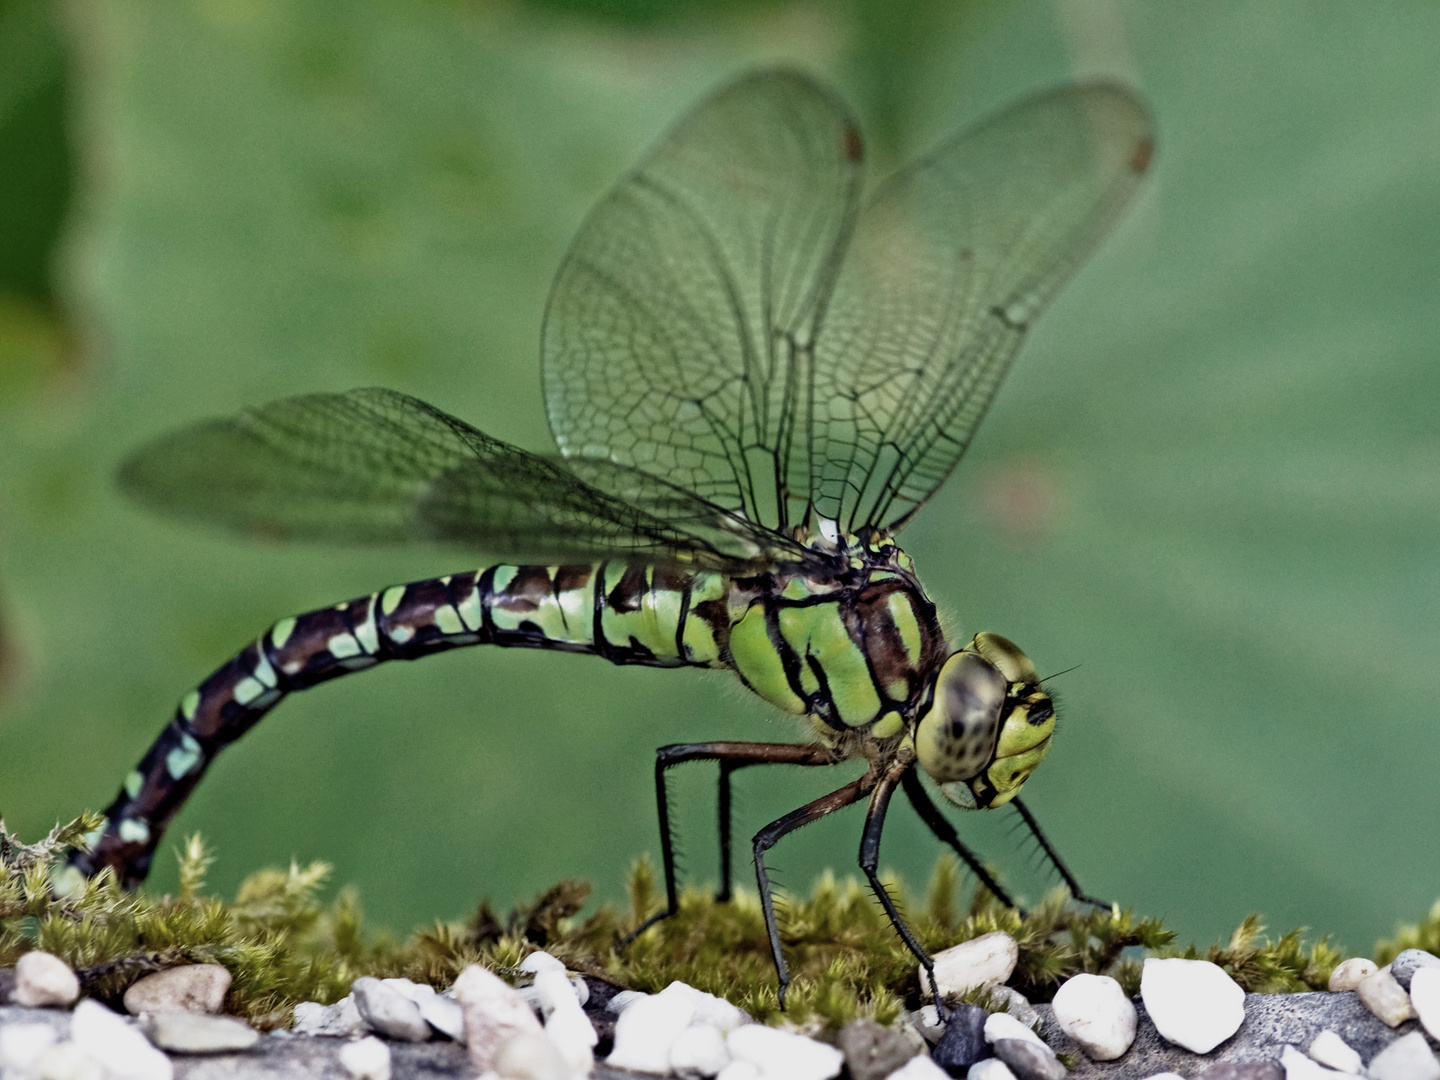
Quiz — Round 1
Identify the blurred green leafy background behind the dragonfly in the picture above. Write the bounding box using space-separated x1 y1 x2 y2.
0 0 1440 950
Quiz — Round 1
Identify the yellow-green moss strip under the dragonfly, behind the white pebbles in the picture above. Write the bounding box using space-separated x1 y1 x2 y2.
0 815 1388 1031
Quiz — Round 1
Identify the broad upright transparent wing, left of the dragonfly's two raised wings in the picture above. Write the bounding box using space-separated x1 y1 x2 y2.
544 71 861 530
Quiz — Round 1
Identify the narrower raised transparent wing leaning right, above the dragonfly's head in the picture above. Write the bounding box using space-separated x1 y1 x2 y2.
812 82 1153 530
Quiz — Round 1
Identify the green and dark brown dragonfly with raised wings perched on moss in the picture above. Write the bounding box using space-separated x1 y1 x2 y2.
68 69 1155 1005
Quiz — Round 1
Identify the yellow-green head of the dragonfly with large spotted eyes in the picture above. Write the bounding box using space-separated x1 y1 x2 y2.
914 634 1056 809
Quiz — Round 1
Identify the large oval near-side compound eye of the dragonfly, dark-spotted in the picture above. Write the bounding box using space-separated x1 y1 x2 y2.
914 651 1009 783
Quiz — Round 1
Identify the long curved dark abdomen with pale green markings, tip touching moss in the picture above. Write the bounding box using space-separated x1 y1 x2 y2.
75 562 729 883
